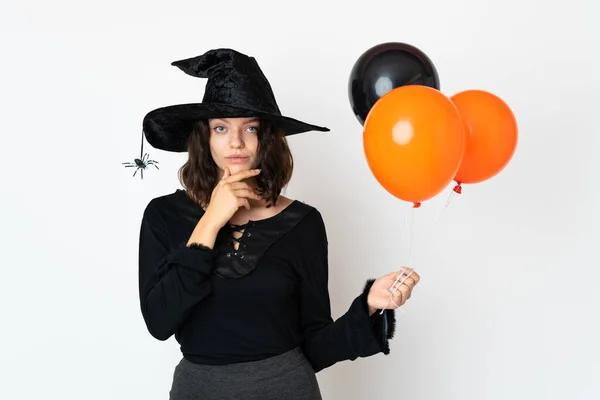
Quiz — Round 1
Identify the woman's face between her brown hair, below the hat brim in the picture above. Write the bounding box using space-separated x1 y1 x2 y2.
208 118 259 175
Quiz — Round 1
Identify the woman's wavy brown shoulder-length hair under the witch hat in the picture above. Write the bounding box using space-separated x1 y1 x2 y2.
178 120 294 207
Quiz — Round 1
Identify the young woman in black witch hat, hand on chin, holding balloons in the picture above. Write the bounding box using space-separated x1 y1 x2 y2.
139 49 419 400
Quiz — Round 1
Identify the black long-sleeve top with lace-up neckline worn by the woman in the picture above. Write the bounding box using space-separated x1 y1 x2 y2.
139 189 395 372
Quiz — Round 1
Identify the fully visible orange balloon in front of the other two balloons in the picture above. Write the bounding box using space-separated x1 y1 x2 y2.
363 85 466 207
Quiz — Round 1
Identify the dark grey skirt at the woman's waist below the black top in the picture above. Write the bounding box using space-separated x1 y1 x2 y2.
169 348 322 400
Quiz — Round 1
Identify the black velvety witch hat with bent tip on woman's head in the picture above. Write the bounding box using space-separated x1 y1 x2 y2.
142 49 329 152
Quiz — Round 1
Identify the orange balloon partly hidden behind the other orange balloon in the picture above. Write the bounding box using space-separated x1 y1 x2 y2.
450 90 518 186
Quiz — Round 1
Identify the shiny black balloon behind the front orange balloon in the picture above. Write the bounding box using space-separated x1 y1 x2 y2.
348 42 440 125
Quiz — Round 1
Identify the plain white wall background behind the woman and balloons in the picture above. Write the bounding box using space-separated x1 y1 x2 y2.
0 0 600 400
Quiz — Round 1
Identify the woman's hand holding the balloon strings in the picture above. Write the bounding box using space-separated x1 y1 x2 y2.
367 267 421 315
